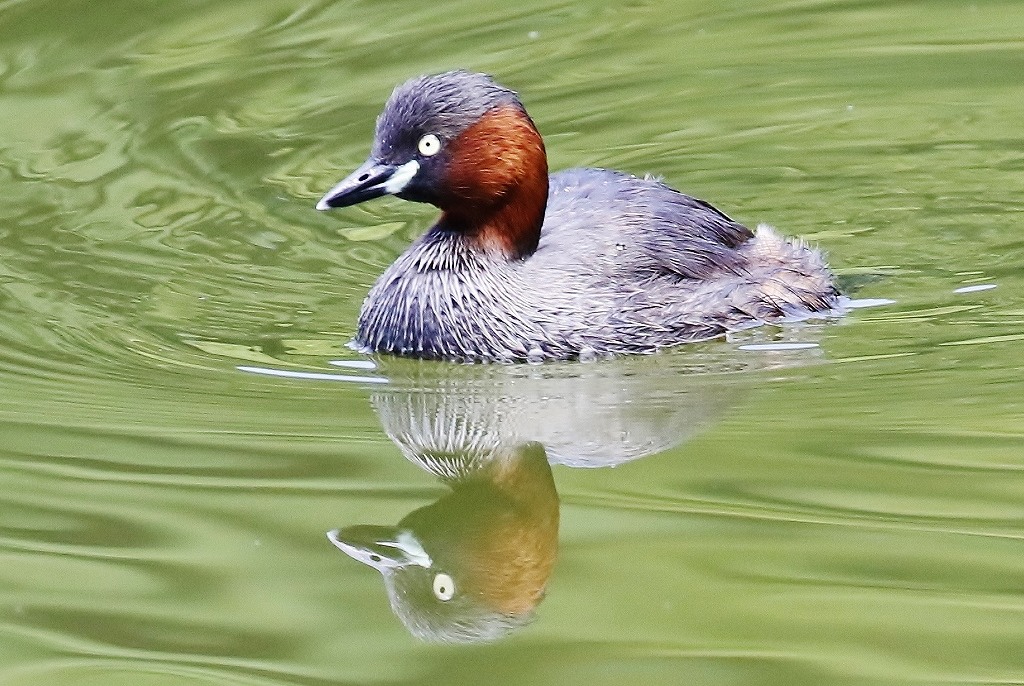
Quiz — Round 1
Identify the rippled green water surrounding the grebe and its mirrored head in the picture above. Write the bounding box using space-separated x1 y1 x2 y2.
0 0 1024 686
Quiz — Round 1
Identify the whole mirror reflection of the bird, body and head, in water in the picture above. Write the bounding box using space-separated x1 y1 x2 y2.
328 350 811 643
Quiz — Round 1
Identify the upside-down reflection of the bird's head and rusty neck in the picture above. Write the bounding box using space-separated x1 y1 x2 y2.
328 443 558 643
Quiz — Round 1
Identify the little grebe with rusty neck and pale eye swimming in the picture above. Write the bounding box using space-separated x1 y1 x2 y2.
316 70 844 362
